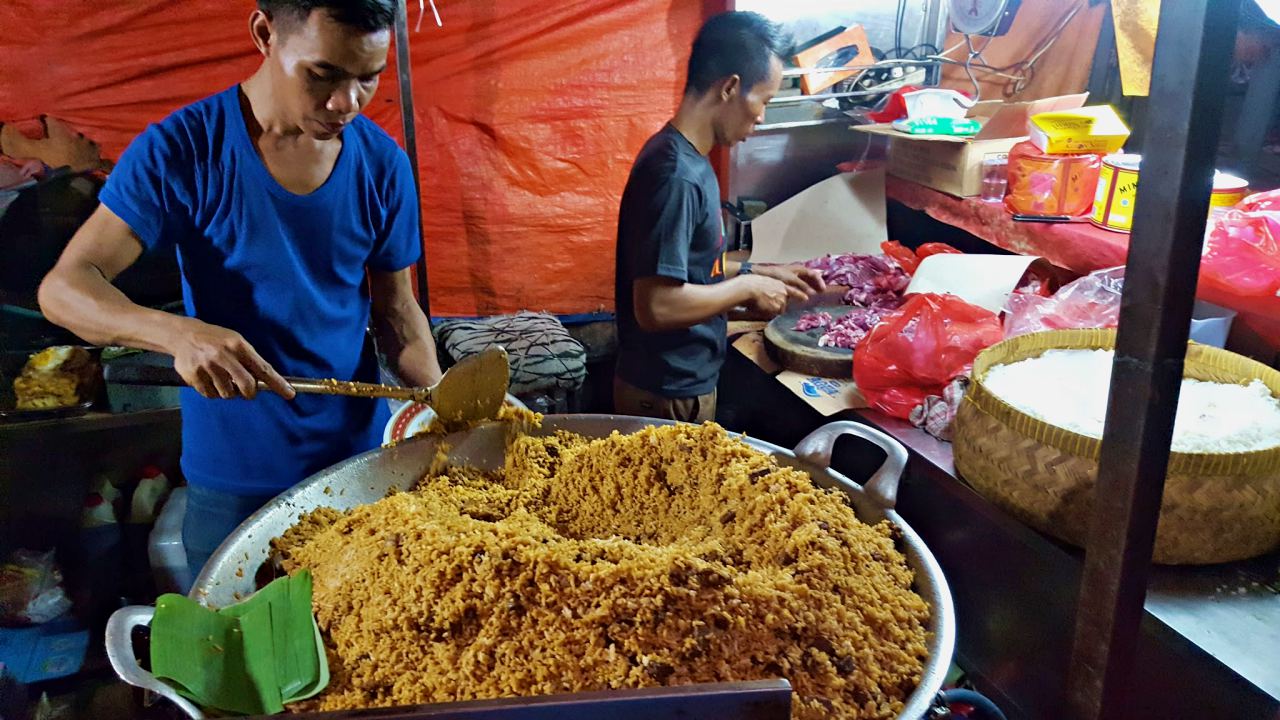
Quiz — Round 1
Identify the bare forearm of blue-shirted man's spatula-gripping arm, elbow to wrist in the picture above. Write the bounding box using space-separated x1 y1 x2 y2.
38 264 186 354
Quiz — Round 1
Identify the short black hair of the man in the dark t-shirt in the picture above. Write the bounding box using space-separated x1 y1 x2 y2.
685 12 791 92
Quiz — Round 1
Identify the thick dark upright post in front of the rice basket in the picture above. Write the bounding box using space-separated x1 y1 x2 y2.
1068 0 1239 720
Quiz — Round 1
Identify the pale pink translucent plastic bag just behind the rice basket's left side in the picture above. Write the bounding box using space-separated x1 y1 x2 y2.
1005 268 1124 338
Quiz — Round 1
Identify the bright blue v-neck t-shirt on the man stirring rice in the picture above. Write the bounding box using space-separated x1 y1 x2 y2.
100 86 421 495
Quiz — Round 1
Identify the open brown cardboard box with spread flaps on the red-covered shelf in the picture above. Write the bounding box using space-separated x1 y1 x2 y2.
854 94 1088 197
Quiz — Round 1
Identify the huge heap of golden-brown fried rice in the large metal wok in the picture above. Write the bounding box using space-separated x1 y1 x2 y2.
273 423 929 719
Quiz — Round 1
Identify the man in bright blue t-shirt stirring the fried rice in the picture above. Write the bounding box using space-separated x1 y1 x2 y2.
40 0 440 571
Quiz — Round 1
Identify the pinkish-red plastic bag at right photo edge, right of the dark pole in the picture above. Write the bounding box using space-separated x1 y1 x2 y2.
1199 190 1280 300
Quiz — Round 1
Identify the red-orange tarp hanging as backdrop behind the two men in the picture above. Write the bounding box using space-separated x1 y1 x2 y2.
0 0 716 315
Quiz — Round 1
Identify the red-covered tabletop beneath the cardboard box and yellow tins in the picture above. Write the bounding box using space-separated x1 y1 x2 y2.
884 176 1280 361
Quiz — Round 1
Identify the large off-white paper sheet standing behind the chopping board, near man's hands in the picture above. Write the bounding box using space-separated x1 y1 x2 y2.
751 169 888 263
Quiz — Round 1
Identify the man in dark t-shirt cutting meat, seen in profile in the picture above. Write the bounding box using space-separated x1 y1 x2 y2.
613 13 823 421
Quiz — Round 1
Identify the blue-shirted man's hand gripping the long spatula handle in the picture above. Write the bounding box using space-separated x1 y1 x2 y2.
170 318 293 400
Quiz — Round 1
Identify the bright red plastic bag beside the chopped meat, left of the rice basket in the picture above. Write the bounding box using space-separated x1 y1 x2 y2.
854 293 1001 419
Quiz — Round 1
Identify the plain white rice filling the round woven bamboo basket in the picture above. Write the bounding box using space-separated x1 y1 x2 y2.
983 350 1280 452
